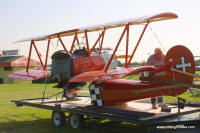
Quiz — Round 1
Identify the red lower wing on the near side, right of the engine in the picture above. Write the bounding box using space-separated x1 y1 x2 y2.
69 66 157 82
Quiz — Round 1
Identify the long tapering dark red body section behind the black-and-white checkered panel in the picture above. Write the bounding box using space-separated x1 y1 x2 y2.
100 79 187 105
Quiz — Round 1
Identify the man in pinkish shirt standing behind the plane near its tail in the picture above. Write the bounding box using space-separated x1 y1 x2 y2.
146 48 165 109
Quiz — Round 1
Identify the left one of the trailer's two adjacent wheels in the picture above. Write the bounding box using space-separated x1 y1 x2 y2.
51 111 66 127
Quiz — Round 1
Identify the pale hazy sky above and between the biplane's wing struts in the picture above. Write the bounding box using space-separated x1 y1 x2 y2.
0 0 200 61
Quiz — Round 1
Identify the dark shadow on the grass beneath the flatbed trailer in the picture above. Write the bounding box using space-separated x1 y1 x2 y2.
0 119 147 133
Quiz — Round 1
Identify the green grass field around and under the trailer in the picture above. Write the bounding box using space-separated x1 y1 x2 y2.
0 77 200 133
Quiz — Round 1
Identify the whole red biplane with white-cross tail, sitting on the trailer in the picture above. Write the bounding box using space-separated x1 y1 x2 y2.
8 13 196 106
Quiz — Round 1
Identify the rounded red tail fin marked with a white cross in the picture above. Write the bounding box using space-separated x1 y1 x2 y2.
165 45 195 83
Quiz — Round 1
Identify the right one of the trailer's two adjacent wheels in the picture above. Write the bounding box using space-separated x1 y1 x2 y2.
69 114 83 129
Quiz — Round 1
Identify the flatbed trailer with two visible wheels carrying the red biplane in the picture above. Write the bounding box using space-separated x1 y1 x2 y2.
12 96 200 131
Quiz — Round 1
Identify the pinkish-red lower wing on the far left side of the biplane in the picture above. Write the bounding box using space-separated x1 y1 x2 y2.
7 69 49 80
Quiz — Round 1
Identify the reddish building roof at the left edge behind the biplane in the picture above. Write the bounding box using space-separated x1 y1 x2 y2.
0 56 41 66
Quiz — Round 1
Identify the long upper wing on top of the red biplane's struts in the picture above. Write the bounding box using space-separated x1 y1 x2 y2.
17 13 178 42
